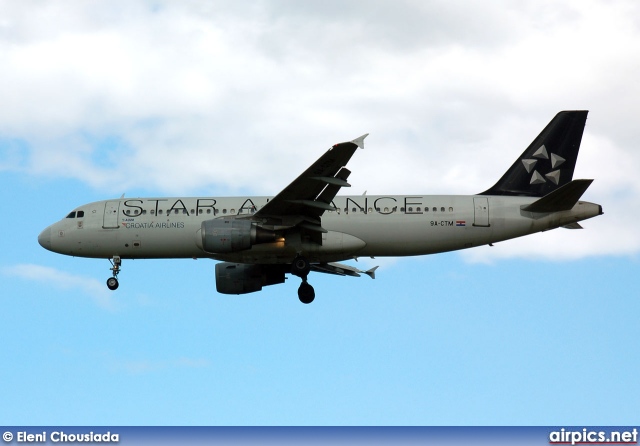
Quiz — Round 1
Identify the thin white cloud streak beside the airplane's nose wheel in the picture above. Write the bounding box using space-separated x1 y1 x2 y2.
0 264 115 310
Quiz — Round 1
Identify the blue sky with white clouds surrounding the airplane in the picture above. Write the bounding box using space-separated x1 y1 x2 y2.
0 1 640 425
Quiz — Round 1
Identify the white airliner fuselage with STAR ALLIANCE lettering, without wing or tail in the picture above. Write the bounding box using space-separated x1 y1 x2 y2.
39 195 602 264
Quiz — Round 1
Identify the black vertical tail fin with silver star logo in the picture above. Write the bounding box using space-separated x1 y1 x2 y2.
479 110 589 197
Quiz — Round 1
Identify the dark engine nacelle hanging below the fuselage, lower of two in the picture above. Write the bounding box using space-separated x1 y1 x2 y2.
216 262 285 294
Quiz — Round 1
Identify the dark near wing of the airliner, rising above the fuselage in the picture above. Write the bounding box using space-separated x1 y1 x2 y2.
252 133 368 238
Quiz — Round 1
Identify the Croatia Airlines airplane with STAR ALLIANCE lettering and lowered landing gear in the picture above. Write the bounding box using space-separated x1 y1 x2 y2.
38 110 603 304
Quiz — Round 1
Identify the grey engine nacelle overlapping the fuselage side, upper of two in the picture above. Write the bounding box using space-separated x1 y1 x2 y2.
200 218 276 253
